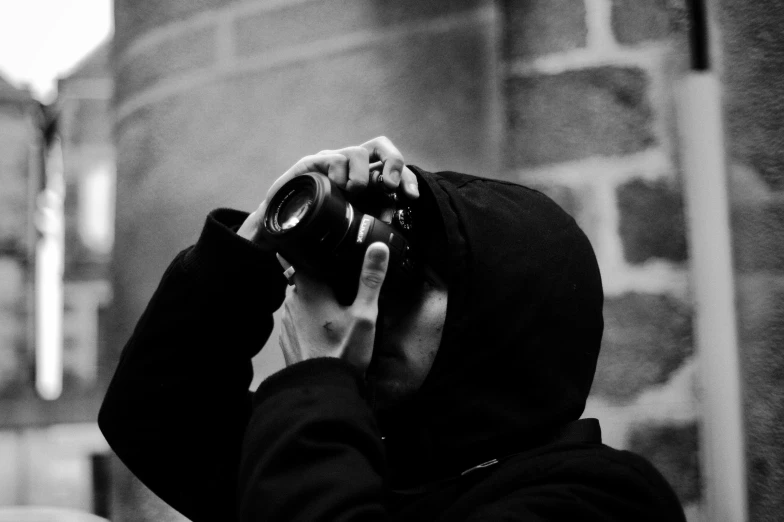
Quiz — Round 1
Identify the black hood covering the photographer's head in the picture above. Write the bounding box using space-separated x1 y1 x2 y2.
377 166 604 485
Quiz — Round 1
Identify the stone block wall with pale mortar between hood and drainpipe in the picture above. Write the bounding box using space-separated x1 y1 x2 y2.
502 0 702 520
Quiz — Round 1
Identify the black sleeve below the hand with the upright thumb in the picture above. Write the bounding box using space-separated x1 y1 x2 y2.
237 358 388 522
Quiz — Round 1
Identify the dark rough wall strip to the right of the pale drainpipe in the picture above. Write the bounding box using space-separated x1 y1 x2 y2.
717 0 784 521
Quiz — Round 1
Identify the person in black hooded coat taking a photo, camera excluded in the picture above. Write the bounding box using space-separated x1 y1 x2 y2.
99 137 685 522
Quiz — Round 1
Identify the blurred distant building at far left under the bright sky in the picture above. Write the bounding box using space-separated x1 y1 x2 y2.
0 39 115 513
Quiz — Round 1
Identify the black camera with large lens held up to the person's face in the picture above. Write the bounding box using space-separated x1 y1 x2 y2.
260 173 421 305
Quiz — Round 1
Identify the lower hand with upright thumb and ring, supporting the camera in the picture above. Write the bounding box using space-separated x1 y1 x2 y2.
278 243 389 376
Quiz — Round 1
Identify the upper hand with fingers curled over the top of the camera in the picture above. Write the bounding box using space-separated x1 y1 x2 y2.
237 136 419 240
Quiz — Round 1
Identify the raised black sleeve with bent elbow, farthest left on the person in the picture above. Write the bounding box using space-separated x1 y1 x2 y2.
98 209 286 522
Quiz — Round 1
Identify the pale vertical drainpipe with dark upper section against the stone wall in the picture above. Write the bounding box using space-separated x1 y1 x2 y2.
678 1 748 522
